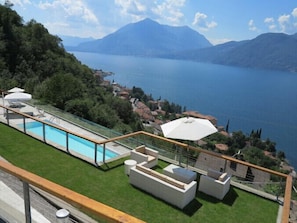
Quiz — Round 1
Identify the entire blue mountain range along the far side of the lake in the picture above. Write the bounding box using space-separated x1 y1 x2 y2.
65 19 297 72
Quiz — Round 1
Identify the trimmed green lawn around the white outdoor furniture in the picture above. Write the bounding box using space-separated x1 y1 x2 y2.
0 124 278 223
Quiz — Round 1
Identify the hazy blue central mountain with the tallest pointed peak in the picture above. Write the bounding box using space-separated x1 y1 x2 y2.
67 19 212 56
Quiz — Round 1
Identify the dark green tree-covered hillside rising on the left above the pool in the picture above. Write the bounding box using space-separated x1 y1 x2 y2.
0 5 141 132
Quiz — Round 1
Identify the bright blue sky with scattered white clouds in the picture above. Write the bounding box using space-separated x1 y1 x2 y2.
0 0 297 45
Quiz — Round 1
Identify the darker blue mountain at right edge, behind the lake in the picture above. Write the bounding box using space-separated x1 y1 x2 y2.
174 33 297 72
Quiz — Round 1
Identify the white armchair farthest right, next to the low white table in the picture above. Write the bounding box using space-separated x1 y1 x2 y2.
198 169 231 200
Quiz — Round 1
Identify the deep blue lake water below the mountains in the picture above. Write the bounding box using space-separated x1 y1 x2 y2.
71 52 297 169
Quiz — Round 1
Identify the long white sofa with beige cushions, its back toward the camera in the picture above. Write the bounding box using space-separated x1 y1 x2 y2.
129 162 197 209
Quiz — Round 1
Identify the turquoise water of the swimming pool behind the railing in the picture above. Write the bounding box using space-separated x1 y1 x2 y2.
20 122 118 162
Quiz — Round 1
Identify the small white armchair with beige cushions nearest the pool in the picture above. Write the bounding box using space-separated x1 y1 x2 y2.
130 145 159 168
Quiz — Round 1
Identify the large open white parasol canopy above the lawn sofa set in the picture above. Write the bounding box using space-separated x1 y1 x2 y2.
161 117 218 141
